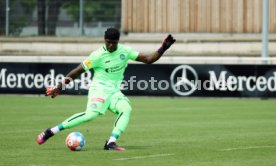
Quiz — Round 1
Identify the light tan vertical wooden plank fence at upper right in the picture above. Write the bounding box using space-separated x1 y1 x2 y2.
122 0 276 33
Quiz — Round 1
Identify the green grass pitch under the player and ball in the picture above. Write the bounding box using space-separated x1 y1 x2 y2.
0 95 276 166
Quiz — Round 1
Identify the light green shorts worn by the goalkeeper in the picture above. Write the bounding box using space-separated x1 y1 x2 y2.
86 89 130 115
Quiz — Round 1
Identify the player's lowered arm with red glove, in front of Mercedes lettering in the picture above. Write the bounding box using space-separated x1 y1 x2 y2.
45 64 85 98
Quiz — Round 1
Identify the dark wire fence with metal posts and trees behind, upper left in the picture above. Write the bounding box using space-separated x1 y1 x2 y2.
0 0 121 36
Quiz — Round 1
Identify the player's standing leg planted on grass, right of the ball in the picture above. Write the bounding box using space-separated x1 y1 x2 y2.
104 93 132 150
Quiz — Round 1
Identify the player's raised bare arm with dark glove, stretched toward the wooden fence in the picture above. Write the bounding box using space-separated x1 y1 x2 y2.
136 35 175 64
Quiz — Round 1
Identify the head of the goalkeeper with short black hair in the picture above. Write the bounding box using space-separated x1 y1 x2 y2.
104 28 120 52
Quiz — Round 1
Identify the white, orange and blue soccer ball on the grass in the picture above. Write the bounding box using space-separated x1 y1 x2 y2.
65 132 85 151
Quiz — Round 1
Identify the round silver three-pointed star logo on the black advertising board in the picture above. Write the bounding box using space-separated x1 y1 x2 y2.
170 65 198 96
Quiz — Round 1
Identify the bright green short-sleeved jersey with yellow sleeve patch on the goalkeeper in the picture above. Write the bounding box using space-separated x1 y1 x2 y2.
82 44 139 91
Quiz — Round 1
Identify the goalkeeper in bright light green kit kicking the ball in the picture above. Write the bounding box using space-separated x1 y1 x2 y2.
37 28 175 151
